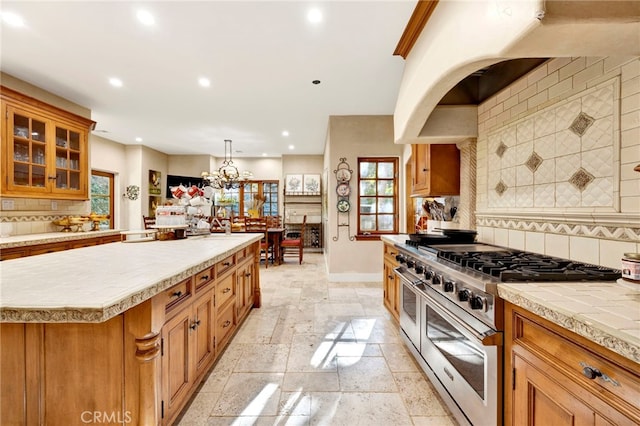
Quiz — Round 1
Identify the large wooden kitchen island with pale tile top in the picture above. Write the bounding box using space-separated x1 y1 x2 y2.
0 234 261 425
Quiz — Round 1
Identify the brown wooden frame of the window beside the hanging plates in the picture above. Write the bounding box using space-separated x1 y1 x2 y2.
356 157 400 240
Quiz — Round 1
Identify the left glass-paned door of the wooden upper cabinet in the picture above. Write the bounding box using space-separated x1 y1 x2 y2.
4 106 53 194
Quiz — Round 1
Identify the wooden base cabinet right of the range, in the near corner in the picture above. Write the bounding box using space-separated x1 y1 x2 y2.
504 303 640 426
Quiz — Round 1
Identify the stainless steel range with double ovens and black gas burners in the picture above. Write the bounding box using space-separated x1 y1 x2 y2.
395 241 621 426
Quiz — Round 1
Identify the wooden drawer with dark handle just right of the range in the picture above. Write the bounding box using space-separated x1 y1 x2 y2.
513 313 640 415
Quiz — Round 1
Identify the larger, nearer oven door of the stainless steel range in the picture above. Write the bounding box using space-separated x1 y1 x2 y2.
420 294 502 425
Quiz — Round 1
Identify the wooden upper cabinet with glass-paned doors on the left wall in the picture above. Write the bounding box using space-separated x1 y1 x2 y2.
0 87 95 200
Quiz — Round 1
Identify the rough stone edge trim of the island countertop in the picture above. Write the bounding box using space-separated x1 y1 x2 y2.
0 234 261 323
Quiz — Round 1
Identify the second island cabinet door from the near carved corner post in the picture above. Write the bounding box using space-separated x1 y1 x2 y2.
191 291 214 377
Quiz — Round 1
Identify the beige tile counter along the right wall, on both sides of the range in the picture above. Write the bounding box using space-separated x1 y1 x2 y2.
382 234 640 363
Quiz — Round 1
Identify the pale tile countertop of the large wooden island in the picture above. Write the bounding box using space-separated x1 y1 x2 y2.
0 234 262 322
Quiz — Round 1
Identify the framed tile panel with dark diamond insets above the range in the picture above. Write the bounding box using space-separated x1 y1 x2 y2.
486 78 619 211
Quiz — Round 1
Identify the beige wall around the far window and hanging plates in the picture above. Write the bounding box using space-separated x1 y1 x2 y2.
325 115 405 281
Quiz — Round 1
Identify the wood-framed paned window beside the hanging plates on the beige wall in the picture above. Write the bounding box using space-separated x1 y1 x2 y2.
358 157 398 239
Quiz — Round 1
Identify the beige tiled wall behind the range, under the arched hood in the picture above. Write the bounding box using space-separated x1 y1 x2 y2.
476 57 640 268
